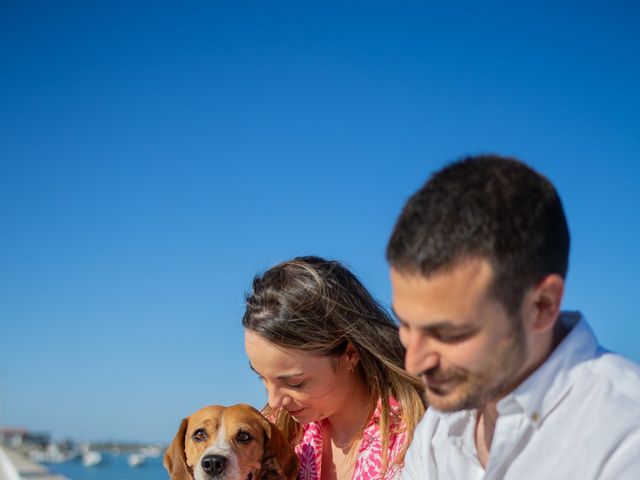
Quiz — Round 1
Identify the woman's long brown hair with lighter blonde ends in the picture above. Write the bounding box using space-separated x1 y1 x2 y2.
242 257 426 471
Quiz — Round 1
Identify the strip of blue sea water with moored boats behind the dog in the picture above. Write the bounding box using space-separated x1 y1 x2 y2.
43 453 169 480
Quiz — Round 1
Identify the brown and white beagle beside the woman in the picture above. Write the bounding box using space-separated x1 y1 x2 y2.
164 404 298 480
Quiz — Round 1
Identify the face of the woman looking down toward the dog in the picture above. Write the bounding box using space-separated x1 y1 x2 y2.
244 330 358 423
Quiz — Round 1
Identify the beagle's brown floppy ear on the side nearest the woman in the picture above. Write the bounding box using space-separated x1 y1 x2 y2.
259 418 298 480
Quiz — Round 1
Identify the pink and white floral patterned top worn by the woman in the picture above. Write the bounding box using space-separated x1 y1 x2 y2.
296 400 407 480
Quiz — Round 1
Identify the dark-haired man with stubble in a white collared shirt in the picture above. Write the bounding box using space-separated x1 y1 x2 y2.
387 156 640 480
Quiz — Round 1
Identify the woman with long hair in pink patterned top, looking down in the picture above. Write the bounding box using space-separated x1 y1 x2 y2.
242 257 425 480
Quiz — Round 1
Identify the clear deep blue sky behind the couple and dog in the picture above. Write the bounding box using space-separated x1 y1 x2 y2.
0 1 640 441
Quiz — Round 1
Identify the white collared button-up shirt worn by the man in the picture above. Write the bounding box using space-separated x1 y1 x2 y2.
402 312 640 480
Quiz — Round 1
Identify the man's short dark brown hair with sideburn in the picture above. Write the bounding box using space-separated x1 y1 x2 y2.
387 155 569 314
